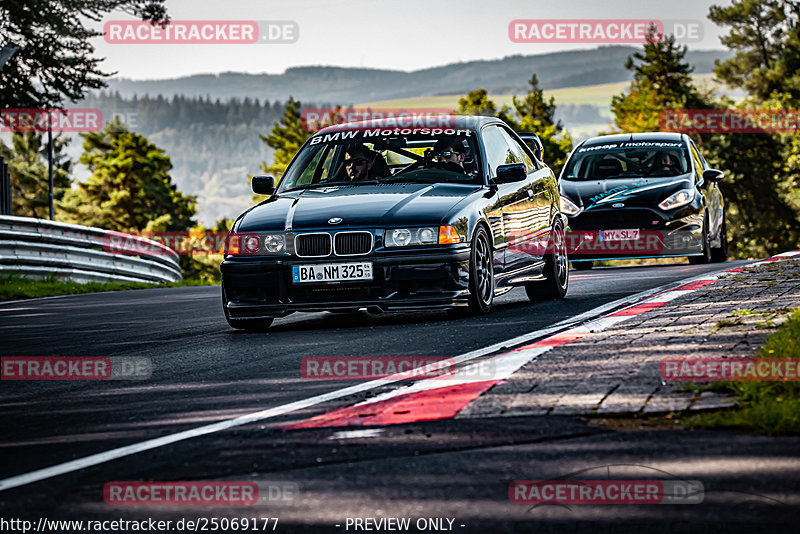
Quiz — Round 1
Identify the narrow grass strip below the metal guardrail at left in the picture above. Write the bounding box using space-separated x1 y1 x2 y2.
0 274 213 301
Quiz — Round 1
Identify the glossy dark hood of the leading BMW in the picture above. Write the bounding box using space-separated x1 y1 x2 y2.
237 183 481 232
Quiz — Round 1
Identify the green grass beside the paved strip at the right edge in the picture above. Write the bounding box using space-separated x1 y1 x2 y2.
684 308 800 435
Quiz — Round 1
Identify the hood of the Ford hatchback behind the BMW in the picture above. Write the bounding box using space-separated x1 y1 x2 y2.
560 174 692 211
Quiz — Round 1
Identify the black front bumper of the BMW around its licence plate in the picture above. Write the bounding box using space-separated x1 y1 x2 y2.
220 247 470 319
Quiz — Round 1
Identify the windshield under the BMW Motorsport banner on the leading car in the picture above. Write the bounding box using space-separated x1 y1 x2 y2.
278 128 483 193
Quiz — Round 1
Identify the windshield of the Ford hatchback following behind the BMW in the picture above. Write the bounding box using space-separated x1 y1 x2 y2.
564 142 690 180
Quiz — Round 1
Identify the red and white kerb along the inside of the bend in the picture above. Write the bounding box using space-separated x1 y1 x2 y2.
281 250 800 430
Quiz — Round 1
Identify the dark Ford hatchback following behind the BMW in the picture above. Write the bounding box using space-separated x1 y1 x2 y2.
559 132 728 269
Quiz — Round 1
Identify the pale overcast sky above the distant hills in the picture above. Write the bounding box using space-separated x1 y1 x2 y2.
95 0 729 79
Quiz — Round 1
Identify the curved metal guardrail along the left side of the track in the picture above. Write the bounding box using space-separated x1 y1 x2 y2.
0 216 182 282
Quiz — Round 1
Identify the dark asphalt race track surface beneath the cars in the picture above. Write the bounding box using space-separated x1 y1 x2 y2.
0 262 796 532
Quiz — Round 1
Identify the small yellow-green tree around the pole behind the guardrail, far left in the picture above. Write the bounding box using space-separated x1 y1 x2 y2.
0 132 72 219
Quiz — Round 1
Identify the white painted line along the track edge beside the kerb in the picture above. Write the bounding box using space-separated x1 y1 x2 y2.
0 262 760 491
